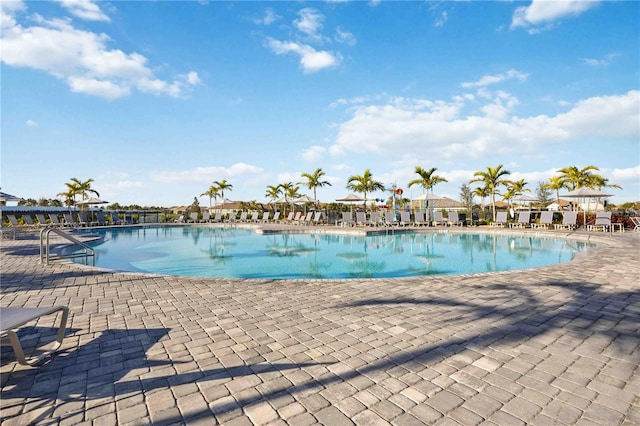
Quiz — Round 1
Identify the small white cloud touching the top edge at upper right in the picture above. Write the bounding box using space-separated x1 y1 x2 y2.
511 0 598 33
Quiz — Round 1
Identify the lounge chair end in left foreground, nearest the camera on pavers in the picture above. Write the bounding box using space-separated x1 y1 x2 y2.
0 306 69 366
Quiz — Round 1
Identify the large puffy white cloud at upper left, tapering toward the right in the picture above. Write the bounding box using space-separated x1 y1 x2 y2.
0 2 200 99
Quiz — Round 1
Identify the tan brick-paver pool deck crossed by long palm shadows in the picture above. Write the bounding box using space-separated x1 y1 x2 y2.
0 227 640 426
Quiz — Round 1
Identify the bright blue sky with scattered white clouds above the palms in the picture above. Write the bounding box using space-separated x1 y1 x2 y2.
0 0 640 207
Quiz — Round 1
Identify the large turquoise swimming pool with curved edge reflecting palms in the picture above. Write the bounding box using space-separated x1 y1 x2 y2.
71 226 592 279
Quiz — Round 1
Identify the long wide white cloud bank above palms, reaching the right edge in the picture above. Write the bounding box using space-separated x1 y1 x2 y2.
329 91 640 161
